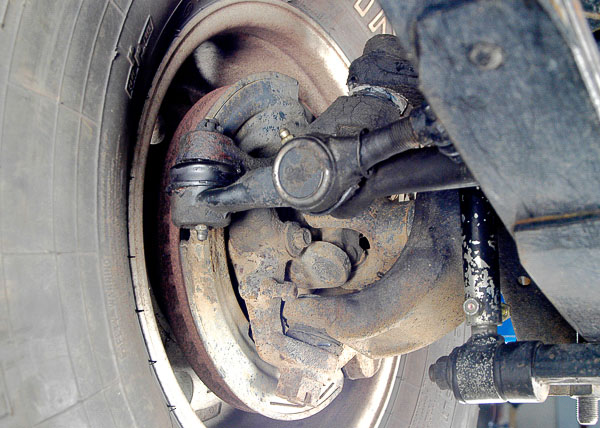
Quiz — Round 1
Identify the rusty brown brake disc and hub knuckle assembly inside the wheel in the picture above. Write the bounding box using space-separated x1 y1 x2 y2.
155 30 462 419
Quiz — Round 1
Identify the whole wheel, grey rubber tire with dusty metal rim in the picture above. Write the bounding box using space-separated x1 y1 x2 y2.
0 0 475 428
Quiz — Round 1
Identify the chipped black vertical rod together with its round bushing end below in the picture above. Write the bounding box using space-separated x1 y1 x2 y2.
429 188 548 404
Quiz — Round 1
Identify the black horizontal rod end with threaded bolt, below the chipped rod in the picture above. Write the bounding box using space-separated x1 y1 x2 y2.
429 335 600 412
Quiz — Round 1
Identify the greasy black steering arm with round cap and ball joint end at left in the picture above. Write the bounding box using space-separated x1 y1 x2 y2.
171 108 474 227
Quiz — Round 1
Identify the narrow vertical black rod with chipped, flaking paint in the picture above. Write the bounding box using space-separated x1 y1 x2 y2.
460 188 502 334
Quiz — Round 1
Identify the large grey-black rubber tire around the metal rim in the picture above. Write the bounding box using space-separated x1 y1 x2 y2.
0 0 474 428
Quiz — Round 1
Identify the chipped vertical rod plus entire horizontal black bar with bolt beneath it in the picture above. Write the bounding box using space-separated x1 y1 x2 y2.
429 188 600 425
